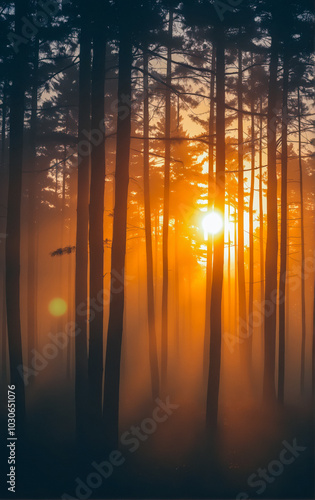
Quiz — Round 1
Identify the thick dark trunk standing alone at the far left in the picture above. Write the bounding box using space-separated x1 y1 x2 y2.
6 0 28 438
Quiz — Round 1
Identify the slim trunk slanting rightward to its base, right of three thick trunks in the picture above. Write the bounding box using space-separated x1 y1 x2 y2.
143 49 159 400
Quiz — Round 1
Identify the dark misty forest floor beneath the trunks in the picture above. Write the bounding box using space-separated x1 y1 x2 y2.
1 376 314 499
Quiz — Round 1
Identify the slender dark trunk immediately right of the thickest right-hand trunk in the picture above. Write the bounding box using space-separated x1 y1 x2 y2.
278 50 289 404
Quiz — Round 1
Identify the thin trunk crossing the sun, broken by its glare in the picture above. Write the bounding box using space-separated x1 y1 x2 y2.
203 44 215 385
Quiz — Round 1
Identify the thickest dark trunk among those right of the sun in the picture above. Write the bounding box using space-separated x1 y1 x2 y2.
263 20 278 402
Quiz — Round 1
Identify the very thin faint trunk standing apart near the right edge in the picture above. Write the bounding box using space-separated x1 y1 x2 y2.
298 87 306 394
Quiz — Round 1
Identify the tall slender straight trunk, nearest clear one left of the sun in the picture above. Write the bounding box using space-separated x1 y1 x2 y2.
161 9 173 391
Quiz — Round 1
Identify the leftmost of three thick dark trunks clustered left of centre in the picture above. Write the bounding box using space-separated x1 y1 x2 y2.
75 2 91 444
